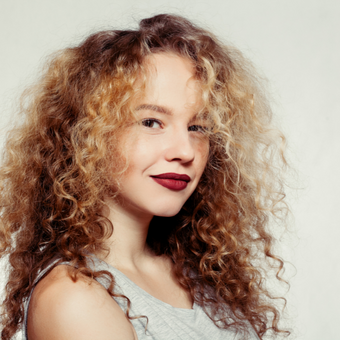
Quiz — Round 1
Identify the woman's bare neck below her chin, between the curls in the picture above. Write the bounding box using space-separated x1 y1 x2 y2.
97 200 153 270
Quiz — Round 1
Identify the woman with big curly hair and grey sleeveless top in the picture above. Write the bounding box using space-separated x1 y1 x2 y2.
0 15 287 340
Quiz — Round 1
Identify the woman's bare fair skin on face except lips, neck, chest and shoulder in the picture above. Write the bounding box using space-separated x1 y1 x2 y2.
28 53 209 340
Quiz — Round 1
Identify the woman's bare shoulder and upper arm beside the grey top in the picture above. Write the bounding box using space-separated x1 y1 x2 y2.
27 265 137 340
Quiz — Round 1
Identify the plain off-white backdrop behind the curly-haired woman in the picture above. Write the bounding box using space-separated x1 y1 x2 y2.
0 0 340 340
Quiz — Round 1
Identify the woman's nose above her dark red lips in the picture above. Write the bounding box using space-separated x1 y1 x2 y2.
165 129 195 164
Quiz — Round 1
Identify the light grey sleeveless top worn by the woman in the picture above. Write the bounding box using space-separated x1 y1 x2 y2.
22 255 259 340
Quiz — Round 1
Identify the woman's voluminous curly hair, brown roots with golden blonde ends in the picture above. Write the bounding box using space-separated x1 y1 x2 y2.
0 14 289 340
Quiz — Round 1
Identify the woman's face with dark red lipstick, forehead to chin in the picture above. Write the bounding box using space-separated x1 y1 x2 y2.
115 53 209 217
